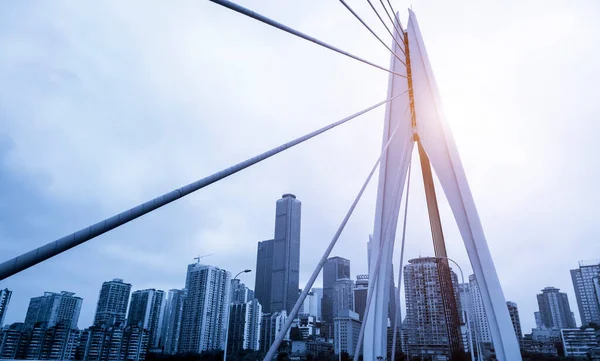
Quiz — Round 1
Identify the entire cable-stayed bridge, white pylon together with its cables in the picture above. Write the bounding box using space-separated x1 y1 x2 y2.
0 0 521 361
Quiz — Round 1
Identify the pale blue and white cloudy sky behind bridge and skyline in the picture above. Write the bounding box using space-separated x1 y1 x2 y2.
0 0 600 332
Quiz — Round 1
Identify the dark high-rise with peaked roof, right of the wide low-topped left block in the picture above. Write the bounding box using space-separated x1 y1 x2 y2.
94 278 131 325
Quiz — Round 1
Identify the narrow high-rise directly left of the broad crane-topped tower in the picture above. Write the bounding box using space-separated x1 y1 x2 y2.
162 289 186 355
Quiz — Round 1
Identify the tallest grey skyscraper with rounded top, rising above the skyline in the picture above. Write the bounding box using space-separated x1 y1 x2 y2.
270 194 302 314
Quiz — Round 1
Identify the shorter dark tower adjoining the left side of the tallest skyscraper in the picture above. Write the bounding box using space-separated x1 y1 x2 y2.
254 239 274 313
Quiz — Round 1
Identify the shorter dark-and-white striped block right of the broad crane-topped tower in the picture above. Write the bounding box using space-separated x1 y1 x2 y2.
227 298 262 356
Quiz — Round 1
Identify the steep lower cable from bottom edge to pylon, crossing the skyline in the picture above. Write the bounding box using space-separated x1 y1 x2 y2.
263 106 406 361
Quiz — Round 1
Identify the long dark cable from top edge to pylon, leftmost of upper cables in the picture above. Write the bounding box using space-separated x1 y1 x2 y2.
210 0 406 78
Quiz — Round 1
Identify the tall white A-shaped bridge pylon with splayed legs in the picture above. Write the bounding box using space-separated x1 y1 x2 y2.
363 10 521 361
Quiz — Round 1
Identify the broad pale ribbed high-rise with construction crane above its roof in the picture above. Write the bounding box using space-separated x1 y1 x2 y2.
178 263 231 353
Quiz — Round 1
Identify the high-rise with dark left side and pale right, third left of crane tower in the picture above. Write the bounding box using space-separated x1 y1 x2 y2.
127 288 165 348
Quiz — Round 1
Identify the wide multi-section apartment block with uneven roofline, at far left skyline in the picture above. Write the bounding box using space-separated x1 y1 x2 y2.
25 291 83 329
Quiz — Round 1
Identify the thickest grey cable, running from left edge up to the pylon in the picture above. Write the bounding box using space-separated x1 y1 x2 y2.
0 92 406 280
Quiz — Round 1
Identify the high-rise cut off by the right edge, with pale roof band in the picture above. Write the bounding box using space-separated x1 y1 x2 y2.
571 260 600 326
